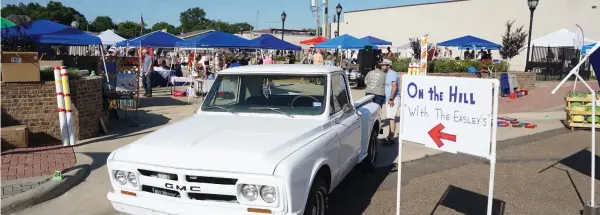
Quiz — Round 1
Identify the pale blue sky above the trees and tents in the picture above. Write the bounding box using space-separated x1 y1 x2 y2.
1 0 442 29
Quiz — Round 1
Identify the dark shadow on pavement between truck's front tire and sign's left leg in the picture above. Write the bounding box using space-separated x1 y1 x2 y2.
329 165 393 215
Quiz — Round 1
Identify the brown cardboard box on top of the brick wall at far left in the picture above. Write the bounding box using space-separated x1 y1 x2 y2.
2 52 40 82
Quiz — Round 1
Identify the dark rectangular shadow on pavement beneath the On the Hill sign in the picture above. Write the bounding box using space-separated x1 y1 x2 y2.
431 185 506 215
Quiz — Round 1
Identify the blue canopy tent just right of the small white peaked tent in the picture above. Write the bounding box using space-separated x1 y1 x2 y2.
115 31 183 48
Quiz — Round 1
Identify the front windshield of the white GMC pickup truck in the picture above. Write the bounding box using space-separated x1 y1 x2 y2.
202 74 327 117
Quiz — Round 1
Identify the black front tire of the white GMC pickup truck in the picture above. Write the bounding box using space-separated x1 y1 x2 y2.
304 177 329 215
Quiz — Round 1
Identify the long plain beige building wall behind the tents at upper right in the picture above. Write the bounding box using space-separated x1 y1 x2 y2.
340 0 600 70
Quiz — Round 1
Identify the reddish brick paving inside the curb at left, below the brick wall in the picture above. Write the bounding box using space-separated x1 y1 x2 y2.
1 146 76 181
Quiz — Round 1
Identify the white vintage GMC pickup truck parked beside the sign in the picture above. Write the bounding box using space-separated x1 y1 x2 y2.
107 64 380 215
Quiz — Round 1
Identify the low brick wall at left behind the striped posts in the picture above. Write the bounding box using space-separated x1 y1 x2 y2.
1 77 102 141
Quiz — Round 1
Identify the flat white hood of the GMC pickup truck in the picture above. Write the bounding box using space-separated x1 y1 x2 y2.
113 115 323 175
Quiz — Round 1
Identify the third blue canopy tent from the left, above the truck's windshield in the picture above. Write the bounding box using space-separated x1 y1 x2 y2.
176 31 257 48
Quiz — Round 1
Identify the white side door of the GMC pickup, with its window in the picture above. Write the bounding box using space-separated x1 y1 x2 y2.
330 73 361 179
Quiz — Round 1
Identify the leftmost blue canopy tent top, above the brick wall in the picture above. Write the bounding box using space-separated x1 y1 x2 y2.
2 19 102 45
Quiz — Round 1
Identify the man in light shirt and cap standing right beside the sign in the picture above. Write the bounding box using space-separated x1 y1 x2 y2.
379 59 400 144
